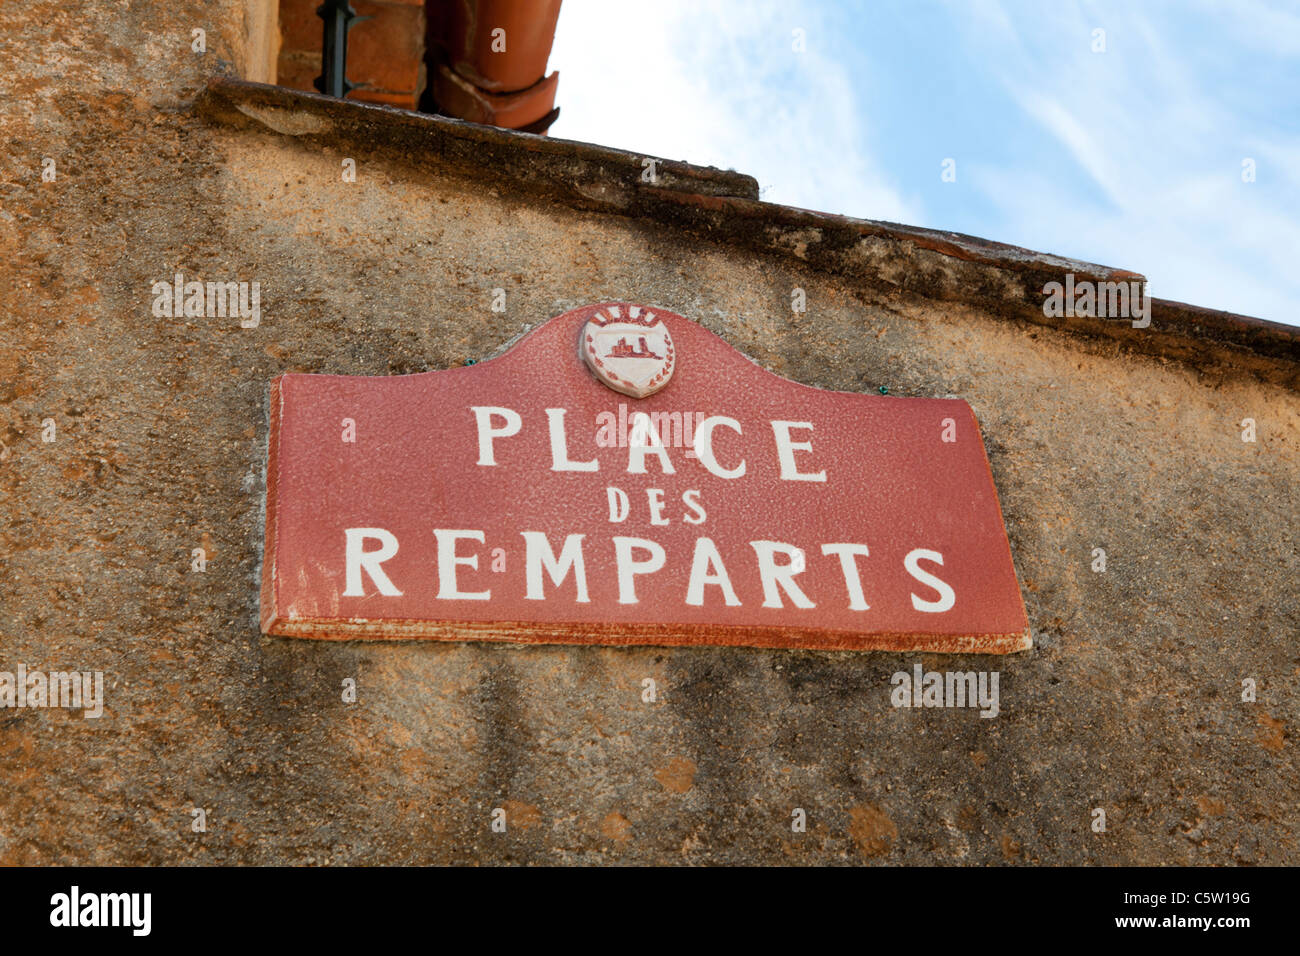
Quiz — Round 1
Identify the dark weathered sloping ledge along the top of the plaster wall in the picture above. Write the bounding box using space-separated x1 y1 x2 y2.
195 77 1300 390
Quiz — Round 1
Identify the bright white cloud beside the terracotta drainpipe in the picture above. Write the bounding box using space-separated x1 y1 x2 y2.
550 0 919 222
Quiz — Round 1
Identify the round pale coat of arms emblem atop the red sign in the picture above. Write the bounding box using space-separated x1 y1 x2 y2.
580 304 676 398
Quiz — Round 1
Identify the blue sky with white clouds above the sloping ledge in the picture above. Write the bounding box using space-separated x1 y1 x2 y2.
550 0 1300 325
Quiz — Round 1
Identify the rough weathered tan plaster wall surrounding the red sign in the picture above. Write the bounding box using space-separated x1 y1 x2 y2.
0 3 1300 864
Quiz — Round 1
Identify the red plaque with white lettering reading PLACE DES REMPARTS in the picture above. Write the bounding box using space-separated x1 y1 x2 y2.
261 303 1030 653
